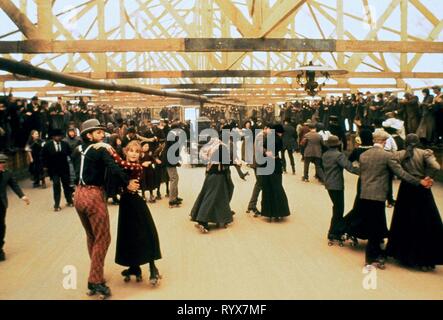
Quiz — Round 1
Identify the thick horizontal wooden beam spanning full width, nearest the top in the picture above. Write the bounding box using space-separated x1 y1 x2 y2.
0 38 443 54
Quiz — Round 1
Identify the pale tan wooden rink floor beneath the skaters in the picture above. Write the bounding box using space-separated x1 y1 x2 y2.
0 156 443 300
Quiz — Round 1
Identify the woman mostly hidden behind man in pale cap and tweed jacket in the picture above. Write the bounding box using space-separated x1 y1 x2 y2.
343 129 373 242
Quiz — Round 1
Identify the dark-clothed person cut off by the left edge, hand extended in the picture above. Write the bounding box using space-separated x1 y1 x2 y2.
0 154 29 261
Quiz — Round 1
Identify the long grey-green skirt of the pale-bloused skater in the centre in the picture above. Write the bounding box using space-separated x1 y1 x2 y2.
191 172 233 224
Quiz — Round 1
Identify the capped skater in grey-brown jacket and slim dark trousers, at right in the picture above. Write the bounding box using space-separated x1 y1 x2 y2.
322 135 359 244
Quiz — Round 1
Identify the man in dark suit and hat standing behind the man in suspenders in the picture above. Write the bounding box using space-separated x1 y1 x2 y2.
42 129 74 212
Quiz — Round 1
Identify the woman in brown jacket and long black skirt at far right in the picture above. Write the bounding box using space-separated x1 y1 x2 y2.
386 134 443 271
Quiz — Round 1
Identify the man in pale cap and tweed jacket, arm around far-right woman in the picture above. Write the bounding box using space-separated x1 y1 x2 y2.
360 130 432 268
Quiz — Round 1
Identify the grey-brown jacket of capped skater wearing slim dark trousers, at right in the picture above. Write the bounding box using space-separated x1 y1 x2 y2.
322 148 359 190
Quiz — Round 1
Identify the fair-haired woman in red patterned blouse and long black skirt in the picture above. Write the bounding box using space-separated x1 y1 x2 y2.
106 140 161 285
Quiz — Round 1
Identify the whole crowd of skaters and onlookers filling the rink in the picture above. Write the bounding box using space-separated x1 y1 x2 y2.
0 87 443 297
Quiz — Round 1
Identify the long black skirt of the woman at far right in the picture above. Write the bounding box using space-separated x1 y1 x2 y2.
386 182 443 266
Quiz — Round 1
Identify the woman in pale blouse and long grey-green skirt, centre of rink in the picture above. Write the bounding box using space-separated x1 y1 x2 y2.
191 138 238 233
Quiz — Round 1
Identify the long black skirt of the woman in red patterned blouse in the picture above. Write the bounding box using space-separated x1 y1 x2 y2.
115 193 161 267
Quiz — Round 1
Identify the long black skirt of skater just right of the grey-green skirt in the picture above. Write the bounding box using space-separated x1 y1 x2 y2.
261 159 290 218
